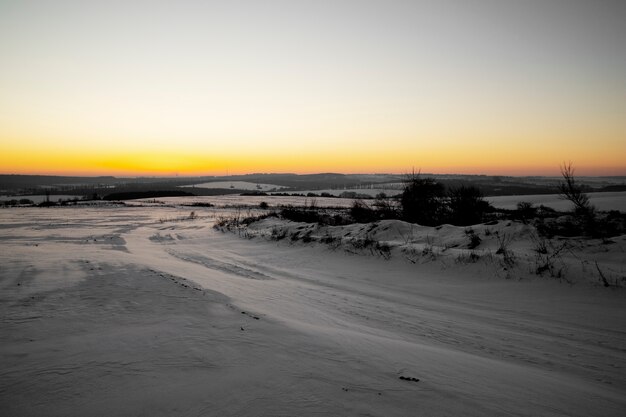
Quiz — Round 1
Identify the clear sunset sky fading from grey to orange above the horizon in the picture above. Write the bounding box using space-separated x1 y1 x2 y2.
0 0 626 176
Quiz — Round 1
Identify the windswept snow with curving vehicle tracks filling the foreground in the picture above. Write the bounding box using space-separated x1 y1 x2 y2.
0 207 626 416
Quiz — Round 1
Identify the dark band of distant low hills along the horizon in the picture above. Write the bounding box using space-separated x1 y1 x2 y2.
0 172 626 196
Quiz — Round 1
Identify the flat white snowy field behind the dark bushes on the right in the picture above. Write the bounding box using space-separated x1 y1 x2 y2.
486 191 626 212
